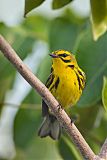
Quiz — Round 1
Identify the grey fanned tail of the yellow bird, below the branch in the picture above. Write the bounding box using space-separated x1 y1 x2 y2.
38 114 61 140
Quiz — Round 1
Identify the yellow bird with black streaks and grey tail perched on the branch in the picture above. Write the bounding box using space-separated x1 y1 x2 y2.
38 50 86 140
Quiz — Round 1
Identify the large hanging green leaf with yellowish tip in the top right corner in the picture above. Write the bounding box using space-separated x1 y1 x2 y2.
90 0 107 40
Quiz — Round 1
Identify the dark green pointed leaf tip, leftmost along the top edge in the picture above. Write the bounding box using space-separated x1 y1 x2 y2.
24 0 45 15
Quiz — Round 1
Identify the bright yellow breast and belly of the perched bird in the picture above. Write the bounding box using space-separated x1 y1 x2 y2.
51 68 82 108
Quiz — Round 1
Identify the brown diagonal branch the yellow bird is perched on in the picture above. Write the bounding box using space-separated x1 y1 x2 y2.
0 35 96 160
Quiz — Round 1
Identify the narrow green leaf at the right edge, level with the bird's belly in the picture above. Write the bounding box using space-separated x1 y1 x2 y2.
102 77 107 111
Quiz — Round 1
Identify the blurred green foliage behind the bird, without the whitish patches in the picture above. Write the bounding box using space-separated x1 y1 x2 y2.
0 4 107 160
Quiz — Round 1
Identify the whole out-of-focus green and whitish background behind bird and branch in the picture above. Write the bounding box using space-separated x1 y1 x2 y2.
0 0 107 160
